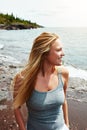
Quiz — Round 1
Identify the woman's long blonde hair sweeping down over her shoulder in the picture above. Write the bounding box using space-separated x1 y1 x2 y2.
14 32 59 108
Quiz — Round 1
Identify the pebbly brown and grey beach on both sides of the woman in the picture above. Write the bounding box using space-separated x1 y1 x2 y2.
0 57 87 130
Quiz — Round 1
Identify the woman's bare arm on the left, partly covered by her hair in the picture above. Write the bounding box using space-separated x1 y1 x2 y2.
13 74 26 130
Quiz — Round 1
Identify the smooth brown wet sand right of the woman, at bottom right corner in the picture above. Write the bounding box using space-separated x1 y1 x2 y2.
68 100 87 130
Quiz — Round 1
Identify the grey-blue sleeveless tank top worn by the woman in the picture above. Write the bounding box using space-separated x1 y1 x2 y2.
26 72 68 130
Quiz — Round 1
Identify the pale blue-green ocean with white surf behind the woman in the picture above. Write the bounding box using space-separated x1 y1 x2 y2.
0 27 87 80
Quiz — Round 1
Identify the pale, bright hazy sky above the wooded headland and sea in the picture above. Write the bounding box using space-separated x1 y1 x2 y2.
0 0 87 27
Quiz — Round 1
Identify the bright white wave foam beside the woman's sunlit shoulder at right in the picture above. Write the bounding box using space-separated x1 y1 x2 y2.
66 66 87 80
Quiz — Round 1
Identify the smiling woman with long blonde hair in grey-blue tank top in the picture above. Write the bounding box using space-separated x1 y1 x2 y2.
14 32 69 130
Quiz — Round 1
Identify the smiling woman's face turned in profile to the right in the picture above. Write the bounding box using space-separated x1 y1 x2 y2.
46 39 64 66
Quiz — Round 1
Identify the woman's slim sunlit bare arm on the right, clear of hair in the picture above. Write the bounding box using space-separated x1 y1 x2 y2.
63 68 69 128
